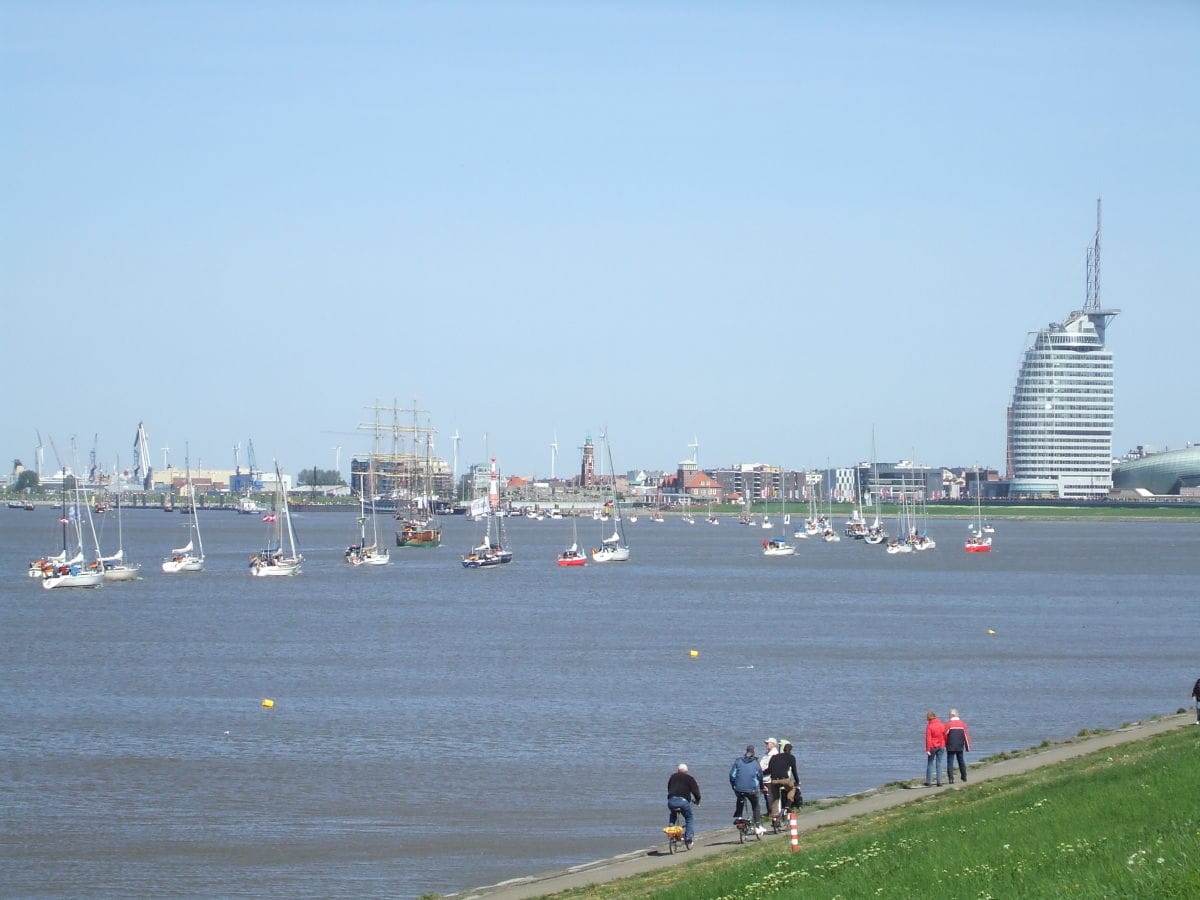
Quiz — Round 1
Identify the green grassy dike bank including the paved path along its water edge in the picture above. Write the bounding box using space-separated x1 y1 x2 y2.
453 713 1200 900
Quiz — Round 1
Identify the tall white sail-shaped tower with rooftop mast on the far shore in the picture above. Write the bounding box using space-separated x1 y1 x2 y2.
1007 200 1120 499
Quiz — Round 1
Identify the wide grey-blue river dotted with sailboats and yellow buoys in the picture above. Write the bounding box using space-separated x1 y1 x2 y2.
0 509 1200 898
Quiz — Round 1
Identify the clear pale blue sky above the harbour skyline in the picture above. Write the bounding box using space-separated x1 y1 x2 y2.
0 0 1200 482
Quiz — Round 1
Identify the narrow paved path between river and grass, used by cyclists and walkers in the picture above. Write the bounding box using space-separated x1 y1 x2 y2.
451 712 1195 900
